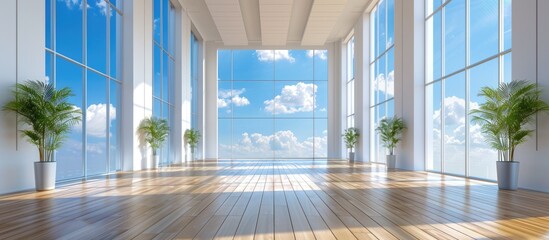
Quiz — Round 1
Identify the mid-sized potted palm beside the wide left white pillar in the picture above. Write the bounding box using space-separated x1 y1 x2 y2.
139 117 170 168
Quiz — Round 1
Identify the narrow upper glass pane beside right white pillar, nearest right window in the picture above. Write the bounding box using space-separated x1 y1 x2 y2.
425 12 442 83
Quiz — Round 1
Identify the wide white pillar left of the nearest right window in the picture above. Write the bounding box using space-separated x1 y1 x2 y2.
395 0 425 170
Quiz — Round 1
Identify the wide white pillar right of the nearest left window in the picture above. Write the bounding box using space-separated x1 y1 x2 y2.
121 0 153 171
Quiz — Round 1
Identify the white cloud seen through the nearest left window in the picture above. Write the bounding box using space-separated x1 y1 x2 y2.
75 103 116 137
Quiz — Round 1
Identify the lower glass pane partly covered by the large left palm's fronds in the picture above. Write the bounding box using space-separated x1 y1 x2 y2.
55 56 84 180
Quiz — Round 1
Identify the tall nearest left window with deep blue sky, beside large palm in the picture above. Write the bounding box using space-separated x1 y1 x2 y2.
46 0 122 181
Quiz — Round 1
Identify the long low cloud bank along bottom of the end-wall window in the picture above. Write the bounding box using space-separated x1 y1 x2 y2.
219 130 328 158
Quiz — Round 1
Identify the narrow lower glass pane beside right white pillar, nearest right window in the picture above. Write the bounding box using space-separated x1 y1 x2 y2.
425 82 442 172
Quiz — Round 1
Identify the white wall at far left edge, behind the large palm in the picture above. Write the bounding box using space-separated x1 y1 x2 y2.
0 0 45 194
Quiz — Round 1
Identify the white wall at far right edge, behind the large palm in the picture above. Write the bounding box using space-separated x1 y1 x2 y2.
512 0 549 192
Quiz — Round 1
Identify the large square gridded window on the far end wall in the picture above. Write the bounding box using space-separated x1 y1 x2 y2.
217 50 328 159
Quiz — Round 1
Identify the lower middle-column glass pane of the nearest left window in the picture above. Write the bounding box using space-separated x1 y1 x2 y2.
86 71 107 175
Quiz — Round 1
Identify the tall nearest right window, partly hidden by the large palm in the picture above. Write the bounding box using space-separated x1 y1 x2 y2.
425 0 511 179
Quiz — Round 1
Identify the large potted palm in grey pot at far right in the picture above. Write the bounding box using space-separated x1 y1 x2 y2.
471 80 549 190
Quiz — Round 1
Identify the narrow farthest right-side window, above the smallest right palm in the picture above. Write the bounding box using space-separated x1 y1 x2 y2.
345 36 355 128
